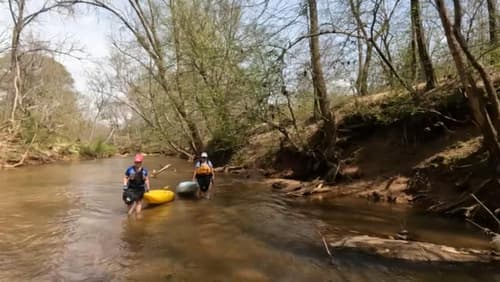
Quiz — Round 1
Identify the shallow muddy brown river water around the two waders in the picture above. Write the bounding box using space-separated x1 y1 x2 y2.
0 157 500 281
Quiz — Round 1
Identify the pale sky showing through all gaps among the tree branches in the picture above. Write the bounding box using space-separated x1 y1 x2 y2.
0 0 414 94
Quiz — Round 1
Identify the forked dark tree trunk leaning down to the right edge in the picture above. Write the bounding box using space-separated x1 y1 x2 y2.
435 0 500 164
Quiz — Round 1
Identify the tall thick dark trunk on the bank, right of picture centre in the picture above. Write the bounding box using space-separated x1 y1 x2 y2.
308 0 336 145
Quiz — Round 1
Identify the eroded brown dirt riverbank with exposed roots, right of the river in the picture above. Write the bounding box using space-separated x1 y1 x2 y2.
227 77 500 227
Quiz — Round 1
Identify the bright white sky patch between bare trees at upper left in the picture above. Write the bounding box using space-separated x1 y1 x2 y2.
0 1 112 94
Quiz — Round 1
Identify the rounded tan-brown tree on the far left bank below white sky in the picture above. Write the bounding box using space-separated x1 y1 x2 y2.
0 52 83 143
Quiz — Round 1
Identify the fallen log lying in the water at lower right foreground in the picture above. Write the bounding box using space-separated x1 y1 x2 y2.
328 235 500 263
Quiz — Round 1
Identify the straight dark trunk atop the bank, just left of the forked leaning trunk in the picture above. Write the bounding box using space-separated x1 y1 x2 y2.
411 0 436 91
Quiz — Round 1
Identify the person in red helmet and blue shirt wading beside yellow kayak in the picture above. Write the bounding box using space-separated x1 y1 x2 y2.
122 154 150 215
